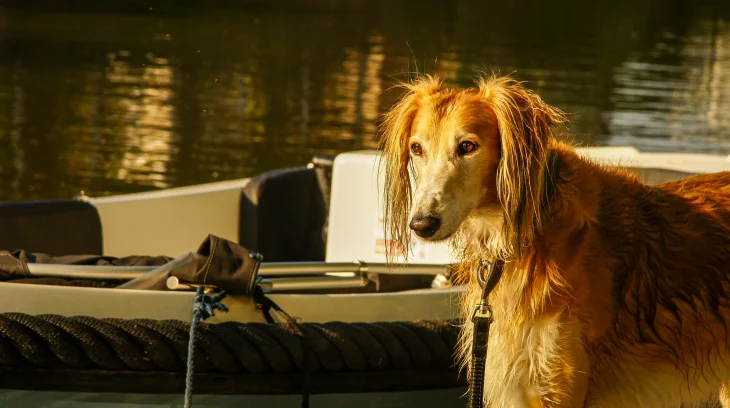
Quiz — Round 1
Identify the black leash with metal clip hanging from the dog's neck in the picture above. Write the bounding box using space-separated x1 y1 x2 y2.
469 259 504 408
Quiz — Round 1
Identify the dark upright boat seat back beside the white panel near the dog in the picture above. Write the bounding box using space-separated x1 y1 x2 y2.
239 158 331 262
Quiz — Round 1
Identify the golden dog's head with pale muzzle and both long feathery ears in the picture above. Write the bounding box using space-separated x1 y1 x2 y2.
381 76 565 258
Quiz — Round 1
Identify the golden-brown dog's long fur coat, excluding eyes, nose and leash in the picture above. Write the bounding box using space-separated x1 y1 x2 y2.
382 75 730 408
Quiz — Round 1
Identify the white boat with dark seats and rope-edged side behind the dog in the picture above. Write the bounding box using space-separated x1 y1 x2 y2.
0 147 730 407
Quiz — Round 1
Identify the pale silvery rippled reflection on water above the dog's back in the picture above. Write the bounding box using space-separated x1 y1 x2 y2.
607 13 730 153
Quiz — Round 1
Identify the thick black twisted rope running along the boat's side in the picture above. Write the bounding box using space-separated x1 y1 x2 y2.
0 313 459 374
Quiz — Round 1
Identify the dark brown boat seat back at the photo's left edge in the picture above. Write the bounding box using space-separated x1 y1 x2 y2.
0 200 103 256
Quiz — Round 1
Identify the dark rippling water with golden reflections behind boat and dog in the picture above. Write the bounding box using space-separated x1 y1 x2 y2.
0 0 730 200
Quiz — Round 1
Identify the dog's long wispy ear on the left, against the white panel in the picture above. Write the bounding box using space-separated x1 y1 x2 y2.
380 76 443 261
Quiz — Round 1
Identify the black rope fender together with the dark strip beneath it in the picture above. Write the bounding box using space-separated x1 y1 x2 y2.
0 313 464 394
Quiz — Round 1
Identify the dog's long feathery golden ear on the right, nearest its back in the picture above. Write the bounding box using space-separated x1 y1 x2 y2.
478 76 567 256
